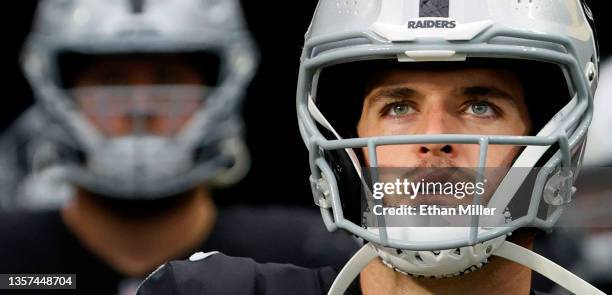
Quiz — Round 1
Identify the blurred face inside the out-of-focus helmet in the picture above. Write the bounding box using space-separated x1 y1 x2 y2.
73 56 206 137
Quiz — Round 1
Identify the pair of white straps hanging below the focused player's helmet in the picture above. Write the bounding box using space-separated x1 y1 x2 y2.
327 241 606 295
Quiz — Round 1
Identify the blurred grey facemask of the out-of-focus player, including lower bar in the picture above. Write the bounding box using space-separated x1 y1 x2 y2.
22 36 258 199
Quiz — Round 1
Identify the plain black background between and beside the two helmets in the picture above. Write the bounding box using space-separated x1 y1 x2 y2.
0 0 612 205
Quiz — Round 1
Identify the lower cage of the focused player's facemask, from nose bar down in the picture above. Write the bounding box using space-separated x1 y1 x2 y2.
311 134 572 250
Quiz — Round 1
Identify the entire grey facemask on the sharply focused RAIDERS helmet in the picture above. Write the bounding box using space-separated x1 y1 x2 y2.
297 27 595 250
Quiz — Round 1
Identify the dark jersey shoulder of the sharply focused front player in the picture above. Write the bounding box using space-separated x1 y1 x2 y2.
138 252 337 295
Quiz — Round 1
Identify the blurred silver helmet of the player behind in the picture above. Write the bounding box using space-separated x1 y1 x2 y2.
22 0 258 200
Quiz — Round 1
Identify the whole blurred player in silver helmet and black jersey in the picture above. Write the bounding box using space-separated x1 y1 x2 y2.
0 0 355 294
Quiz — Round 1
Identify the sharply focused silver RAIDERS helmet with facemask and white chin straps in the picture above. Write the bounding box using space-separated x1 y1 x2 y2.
296 0 599 294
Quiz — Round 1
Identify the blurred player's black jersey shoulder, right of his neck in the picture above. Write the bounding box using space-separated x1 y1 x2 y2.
213 207 359 268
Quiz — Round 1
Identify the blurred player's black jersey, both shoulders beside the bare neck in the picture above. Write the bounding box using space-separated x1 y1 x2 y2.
0 208 358 295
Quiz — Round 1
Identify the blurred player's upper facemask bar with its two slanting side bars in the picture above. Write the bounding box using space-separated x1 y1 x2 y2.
22 36 257 153
